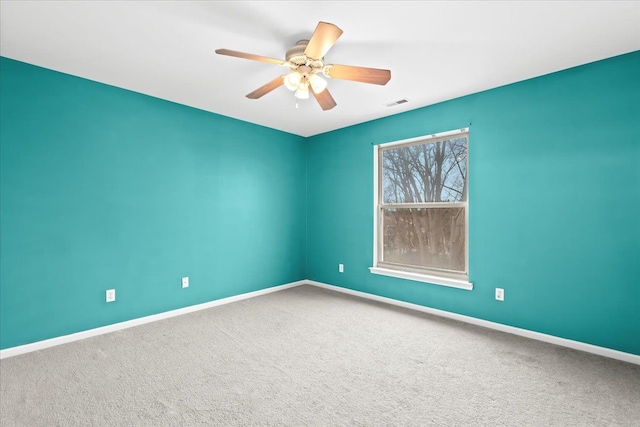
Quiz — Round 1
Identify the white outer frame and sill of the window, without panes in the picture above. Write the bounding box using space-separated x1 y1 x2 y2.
369 128 473 290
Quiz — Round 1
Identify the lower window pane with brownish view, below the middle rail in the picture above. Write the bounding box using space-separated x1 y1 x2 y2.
382 208 466 272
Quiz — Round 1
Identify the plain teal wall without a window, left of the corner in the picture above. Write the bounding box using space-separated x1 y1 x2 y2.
0 58 306 348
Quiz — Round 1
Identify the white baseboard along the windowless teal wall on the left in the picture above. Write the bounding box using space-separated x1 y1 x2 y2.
0 280 307 359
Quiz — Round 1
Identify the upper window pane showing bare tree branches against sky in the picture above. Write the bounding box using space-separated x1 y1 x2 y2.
382 136 467 203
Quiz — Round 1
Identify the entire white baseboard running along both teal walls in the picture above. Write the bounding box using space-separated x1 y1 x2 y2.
0 280 640 365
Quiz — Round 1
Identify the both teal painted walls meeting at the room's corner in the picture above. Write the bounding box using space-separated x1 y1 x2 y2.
0 52 640 354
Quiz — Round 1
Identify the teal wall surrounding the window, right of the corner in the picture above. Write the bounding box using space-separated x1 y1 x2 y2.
307 52 640 354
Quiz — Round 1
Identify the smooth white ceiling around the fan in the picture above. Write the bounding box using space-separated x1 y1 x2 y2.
0 1 640 136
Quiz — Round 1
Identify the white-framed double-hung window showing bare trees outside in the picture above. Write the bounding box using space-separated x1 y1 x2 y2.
370 129 472 289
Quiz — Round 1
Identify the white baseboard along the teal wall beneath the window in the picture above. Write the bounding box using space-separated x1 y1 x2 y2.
305 280 640 365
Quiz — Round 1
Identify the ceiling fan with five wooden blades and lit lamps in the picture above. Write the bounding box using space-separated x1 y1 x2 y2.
216 22 391 111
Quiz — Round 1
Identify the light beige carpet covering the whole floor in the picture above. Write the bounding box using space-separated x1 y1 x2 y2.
0 286 640 427
